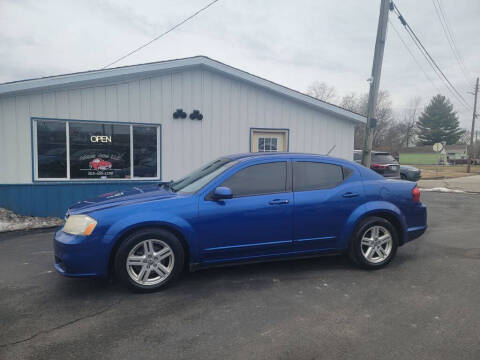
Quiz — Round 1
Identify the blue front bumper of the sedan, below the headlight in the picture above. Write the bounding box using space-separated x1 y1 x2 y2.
53 230 109 277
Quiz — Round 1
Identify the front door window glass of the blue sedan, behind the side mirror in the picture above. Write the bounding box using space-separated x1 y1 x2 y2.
221 161 287 197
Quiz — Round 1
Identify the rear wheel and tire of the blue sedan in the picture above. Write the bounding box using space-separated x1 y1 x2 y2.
348 216 398 270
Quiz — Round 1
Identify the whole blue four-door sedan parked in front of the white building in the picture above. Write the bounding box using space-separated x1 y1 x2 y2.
54 153 427 291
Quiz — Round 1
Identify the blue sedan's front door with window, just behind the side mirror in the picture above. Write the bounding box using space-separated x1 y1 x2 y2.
196 161 293 262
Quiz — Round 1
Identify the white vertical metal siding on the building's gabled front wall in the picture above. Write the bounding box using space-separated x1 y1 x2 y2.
0 69 354 184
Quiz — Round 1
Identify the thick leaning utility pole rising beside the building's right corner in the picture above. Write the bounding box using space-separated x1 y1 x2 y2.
362 0 393 167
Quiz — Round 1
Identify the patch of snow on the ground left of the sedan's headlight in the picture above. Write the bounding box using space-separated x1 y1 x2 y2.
0 208 63 232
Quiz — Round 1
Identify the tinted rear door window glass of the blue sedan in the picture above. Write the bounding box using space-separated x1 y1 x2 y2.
293 161 344 191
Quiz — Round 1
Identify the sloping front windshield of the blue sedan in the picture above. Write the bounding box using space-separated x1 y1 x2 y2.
169 158 237 194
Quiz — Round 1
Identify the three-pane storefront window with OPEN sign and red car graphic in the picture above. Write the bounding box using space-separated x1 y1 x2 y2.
35 119 159 180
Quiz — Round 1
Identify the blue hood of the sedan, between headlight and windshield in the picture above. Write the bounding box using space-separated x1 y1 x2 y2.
67 184 178 216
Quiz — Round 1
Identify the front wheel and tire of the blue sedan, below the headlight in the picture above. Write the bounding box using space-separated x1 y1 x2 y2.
115 228 185 292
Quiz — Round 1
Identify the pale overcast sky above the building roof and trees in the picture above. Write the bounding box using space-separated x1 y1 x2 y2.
0 0 480 128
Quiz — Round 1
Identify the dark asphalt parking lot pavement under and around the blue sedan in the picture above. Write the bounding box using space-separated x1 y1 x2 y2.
0 193 480 360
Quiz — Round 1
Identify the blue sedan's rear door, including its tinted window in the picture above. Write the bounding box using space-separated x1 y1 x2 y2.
292 161 363 251
